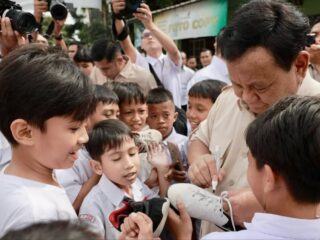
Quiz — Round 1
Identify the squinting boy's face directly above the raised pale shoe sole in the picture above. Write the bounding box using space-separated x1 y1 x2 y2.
120 101 148 132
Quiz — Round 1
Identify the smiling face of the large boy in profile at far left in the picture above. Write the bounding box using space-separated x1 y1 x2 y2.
31 117 88 169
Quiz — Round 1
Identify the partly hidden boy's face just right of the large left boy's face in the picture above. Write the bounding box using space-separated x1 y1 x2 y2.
87 102 119 129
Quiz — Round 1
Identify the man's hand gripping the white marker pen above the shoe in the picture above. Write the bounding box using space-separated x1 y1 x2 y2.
188 154 223 188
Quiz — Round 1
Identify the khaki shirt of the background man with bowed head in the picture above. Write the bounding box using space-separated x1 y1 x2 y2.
107 59 157 95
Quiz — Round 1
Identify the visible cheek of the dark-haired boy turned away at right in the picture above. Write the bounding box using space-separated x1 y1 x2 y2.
247 151 264 205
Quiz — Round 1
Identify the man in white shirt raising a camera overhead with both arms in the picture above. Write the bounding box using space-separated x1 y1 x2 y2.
112 0 182 107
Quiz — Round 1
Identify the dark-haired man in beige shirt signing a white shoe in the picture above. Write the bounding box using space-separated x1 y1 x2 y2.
188 0 320 234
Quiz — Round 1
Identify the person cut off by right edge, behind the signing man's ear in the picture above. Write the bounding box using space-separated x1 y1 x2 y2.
306 17 320 82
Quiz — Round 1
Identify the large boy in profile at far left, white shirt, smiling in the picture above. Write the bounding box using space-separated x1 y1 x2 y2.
0 44 94 236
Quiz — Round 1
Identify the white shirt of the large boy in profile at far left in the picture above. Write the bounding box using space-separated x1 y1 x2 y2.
0 167 77 237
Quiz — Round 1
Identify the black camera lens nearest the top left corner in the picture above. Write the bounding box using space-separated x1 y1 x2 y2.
5 9 38 34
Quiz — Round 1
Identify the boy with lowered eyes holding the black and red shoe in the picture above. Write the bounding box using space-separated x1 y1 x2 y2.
79 119 169 239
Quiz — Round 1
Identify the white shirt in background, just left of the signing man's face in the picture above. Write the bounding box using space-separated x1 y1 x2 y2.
187 56 230 93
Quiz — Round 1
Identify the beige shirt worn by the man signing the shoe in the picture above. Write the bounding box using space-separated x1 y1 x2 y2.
191 73 320 194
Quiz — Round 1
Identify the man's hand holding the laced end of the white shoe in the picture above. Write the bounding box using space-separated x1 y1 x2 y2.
224 189 264 226
